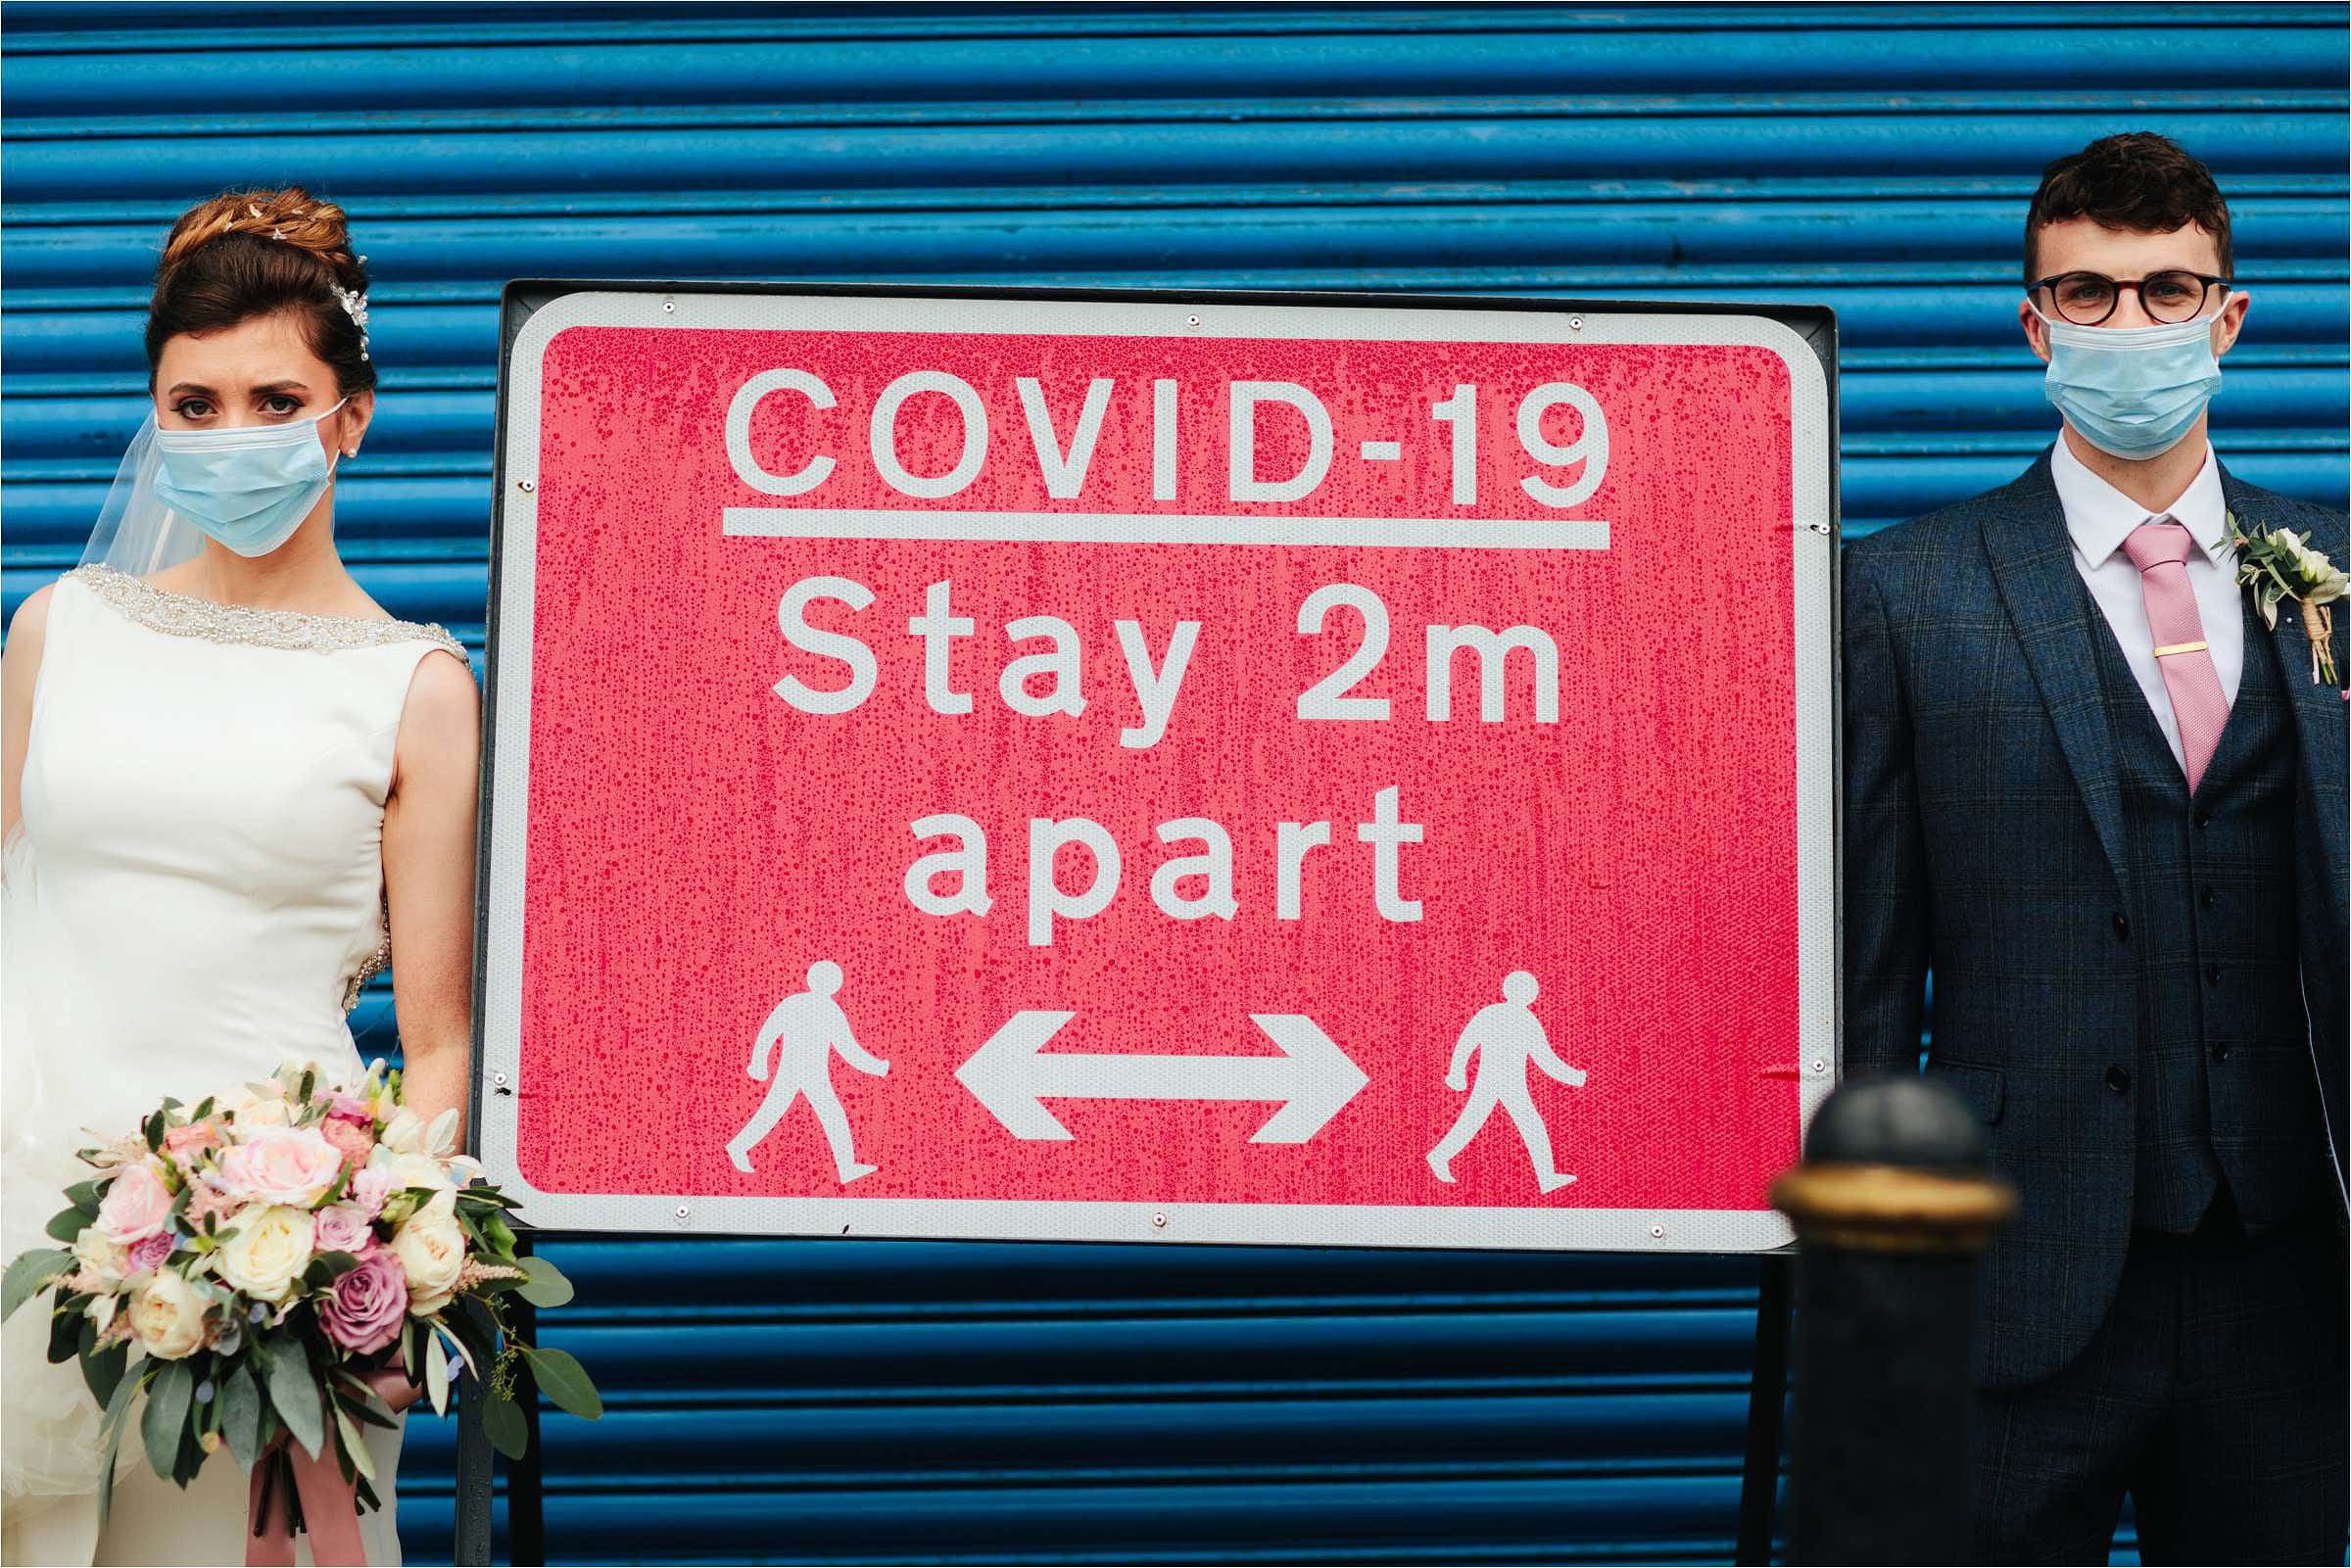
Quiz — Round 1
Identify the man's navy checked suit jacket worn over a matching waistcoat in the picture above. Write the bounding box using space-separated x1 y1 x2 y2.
1844 453 2351 1387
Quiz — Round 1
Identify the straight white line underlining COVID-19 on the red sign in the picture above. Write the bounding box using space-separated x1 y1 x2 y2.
722 505 1608 550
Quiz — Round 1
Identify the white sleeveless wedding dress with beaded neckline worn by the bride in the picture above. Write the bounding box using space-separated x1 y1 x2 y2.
0 566 463 1563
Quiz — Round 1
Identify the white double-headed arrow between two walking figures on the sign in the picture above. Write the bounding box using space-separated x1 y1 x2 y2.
954 1011 1370 1143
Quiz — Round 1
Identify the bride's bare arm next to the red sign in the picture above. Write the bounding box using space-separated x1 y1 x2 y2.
383 653 482 1142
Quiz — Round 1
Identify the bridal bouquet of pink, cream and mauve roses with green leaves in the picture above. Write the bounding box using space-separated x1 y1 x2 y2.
0 1061 604 1528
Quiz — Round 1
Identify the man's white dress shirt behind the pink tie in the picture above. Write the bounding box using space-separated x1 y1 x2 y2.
2050 433 2245 774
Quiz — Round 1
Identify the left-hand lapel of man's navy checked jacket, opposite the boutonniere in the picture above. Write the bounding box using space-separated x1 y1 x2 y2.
1982 453 2130 896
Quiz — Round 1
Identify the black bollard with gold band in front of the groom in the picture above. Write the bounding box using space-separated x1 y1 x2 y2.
1770 1076 2015 1563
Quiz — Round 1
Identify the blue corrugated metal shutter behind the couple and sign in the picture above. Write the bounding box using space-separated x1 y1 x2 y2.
0 5 2351 1563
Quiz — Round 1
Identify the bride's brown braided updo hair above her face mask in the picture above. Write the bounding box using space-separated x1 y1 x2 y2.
146 186 376 398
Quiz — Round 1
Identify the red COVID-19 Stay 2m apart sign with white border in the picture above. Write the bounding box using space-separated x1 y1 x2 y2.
482 289 1836 1249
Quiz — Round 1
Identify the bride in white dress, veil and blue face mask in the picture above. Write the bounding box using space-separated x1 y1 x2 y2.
0 188 480 1563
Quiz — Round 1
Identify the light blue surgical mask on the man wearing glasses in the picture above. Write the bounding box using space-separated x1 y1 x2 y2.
2034 306 2220 458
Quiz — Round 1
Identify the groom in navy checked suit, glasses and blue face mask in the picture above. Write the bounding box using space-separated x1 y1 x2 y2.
1844 134 2351 1563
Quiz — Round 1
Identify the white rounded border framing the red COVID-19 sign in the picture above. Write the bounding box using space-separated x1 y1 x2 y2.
475 287 1839 1253
